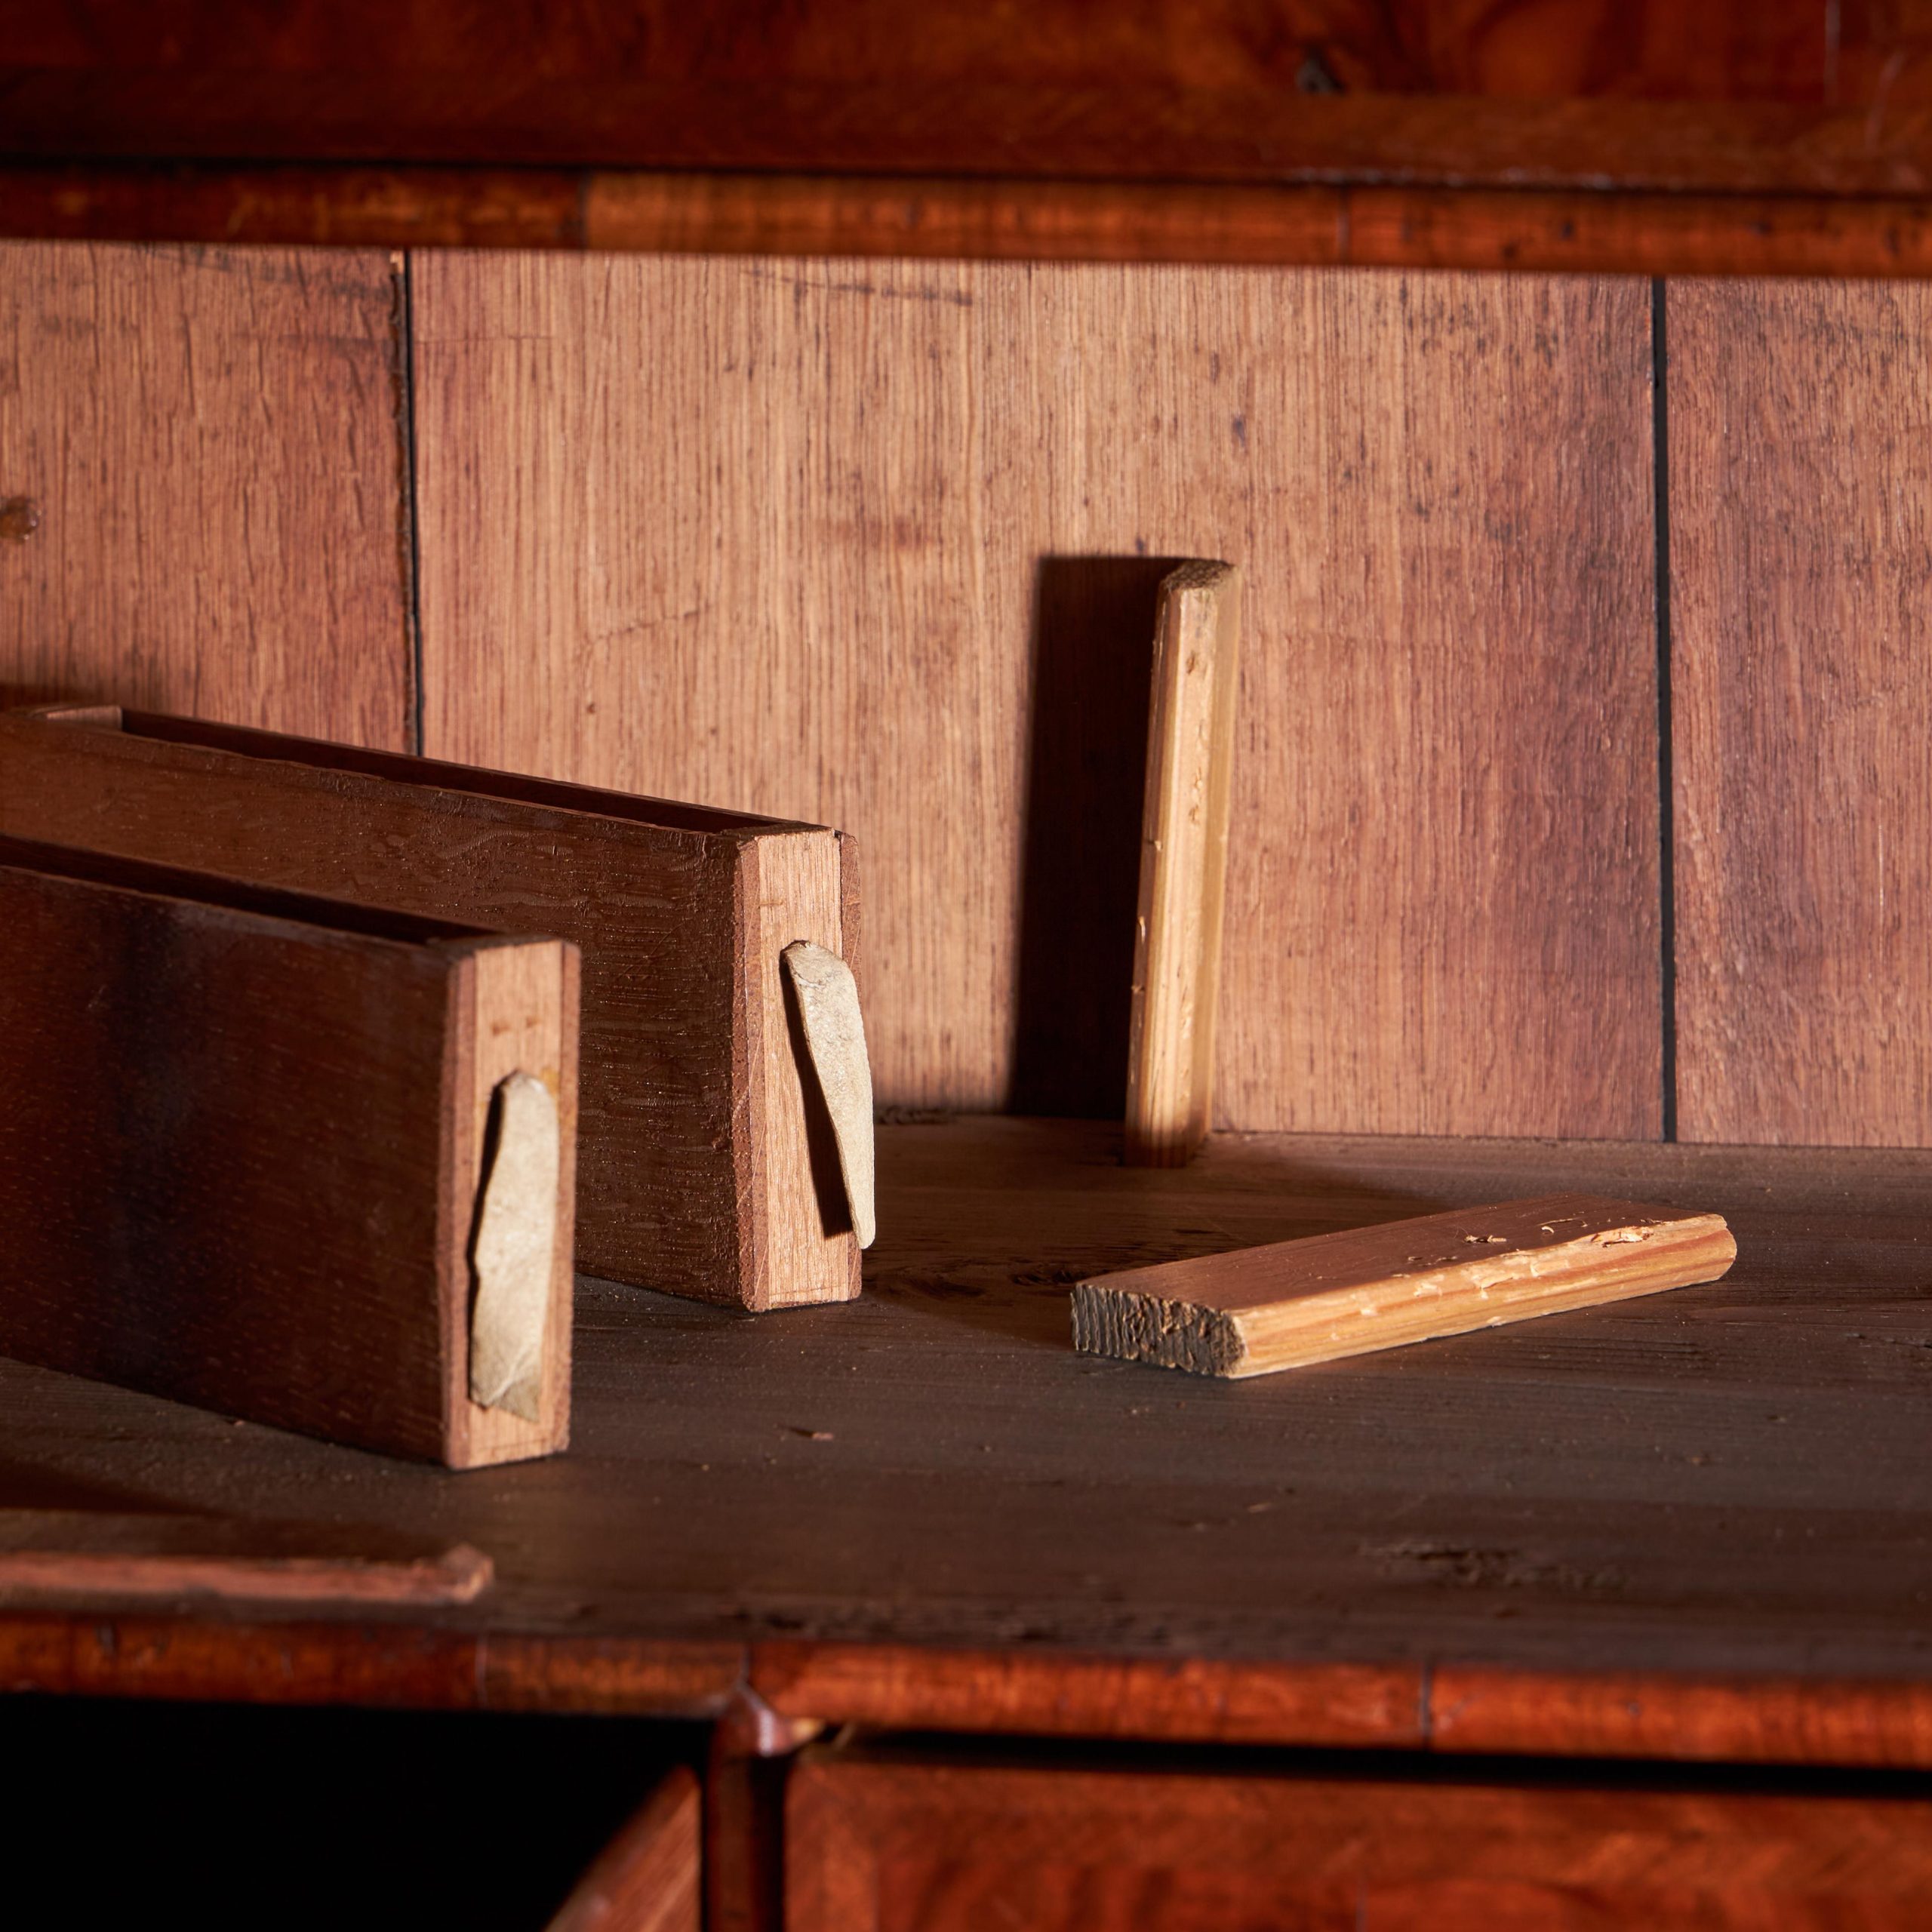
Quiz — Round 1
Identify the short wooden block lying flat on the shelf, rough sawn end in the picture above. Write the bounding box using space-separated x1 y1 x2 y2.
1072 1194 1737 1377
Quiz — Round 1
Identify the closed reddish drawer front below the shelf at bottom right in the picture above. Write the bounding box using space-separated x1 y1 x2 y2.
786 1750 1932 1932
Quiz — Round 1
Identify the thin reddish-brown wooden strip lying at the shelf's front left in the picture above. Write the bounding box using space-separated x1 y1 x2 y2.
0 1509 493 1605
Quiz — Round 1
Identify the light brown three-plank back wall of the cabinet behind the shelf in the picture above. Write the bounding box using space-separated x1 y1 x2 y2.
0 245 1932 1144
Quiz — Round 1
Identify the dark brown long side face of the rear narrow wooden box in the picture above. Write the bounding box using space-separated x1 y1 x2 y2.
0 718 744 1300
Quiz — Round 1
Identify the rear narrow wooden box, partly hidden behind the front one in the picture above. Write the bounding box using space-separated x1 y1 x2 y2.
0 705 860 1310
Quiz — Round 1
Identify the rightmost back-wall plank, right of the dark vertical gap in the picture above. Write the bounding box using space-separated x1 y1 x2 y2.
1669 282 1932 1146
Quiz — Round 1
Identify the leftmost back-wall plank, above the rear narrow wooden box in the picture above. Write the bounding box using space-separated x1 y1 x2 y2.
0 244 410 746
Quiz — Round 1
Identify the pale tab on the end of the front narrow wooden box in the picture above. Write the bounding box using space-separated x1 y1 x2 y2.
469 1072 562 1422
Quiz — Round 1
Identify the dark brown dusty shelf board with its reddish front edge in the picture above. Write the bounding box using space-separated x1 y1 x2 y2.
0 1118 1932 1762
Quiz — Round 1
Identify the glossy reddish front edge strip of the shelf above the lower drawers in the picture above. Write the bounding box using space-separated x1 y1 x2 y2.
0 1609 1932 1770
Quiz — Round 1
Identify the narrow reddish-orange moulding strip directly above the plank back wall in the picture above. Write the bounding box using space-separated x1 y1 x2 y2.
11 162 1932 276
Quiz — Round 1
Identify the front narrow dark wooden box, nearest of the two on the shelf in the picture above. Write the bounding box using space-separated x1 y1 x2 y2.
0 838 576 1469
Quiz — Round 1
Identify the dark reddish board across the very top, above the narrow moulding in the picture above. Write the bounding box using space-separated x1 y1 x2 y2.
0 0 1932 193
